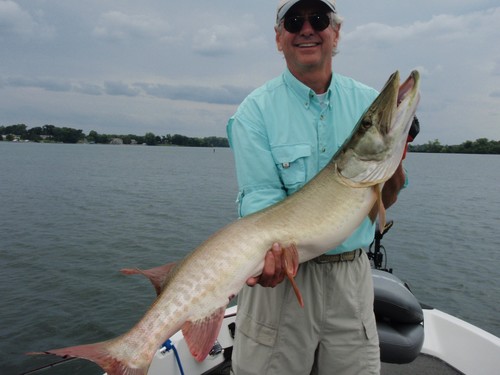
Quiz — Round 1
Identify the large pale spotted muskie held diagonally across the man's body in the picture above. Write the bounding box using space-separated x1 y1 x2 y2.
31 71 419 375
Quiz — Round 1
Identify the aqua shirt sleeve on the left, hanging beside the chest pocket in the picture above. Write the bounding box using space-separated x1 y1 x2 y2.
227 111 286 217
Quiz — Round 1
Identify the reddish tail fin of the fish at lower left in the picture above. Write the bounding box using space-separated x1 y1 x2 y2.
27 340 149 375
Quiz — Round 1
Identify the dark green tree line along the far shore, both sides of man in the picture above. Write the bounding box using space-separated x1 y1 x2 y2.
0 124 500 154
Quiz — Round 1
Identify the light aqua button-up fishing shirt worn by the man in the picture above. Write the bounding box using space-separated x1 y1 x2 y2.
227 69 378 254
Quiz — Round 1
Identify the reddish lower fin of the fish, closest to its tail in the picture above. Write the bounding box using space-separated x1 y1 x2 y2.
182 306 226 362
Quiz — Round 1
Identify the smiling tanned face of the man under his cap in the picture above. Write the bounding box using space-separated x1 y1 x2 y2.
276 2 340 73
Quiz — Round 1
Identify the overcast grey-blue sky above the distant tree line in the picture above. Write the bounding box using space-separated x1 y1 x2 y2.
0 0 500 144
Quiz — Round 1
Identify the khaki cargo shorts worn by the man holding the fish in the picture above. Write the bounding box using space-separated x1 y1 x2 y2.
232 252 380 375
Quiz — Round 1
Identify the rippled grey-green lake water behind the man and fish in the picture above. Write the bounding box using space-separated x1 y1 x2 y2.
0 142 500 375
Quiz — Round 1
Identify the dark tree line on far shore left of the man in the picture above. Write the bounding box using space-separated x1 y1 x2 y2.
0 124 229 147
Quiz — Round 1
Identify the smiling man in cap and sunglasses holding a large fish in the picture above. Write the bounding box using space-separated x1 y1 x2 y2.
227 0 405 375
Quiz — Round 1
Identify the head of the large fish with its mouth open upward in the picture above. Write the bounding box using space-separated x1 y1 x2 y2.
332 70 420 187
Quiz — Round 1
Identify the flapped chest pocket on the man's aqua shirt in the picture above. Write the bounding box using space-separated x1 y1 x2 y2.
271 144 311 194
